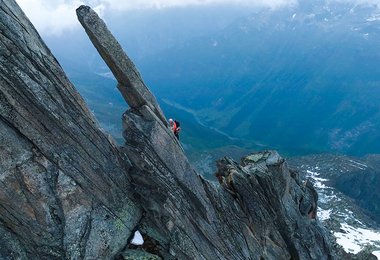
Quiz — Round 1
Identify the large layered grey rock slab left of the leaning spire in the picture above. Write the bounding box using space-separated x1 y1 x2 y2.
0 0 141 259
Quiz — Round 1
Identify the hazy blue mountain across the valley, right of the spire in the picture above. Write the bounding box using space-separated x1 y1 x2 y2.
137 1 380 155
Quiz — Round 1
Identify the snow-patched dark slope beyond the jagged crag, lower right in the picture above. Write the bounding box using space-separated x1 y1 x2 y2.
289 154 380 257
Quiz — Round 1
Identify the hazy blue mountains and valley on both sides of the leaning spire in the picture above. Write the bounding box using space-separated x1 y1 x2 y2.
43 1 380 155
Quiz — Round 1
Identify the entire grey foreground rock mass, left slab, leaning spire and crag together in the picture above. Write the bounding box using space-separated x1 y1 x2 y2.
0 0 334 259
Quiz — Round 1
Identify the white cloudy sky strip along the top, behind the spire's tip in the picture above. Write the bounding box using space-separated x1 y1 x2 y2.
16 0 300 35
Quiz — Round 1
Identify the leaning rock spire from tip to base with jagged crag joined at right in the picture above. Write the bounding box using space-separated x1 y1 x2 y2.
77 6 333 259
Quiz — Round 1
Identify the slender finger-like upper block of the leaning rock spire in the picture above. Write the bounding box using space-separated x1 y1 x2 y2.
77 5 167 126
